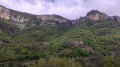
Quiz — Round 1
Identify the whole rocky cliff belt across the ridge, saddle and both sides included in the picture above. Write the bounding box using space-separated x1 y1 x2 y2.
0 6 120 28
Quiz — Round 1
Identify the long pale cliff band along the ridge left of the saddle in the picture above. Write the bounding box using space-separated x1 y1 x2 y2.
0 6 69 23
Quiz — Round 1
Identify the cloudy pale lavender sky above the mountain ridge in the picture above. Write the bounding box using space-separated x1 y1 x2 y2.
0 0 120 19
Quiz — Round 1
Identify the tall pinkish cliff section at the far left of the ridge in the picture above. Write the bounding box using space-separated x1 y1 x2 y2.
0 6 34 22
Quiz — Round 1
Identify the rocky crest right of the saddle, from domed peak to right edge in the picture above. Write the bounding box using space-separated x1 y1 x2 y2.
76 10 120 22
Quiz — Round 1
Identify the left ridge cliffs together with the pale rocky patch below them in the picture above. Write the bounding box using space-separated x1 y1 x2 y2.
0 6 71 28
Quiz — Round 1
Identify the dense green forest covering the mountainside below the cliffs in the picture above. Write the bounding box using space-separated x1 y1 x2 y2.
0 16 120 67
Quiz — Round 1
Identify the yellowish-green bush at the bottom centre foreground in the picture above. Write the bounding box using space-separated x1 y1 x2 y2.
32 57 82 67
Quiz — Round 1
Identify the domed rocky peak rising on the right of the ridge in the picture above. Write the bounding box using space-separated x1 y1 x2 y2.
85 10 109 21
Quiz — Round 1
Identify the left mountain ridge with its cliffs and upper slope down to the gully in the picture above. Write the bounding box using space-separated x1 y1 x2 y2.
0 6 72 36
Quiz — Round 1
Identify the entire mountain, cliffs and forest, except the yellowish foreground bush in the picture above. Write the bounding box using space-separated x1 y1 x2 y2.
0 6 120 67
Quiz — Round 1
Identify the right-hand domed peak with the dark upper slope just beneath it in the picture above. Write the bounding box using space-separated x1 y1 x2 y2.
73 10 120 27
